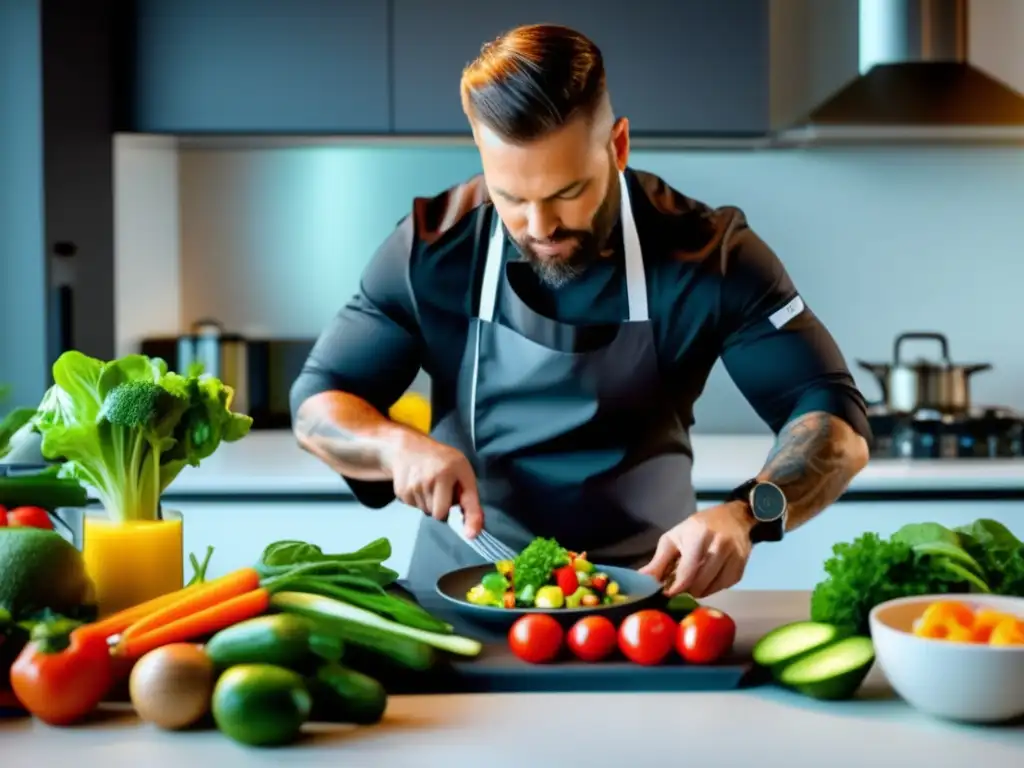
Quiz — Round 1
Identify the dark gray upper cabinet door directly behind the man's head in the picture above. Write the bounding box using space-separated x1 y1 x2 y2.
392 0 769 136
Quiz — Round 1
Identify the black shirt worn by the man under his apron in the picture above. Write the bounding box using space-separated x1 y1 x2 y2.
292 169 870 506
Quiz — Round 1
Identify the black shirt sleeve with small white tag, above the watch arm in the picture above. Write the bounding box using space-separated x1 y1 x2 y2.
719 219 871 440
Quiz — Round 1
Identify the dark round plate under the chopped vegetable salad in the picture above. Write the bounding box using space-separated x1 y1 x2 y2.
436 563 665 628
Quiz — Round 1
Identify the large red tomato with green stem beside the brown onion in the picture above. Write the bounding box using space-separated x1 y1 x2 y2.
10 620 114 725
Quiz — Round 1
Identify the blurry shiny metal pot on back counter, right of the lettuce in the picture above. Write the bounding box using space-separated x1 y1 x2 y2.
177 318 250 414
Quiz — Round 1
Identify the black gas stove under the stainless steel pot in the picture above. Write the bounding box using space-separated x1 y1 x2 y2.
868 407 1024 459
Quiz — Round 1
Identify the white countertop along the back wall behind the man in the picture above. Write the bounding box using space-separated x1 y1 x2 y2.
161 431 1024 497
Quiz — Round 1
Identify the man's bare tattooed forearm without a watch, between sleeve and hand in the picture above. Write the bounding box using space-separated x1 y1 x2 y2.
293 392 399 480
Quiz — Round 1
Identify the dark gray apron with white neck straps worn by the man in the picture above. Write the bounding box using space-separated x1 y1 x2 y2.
407 173 696 606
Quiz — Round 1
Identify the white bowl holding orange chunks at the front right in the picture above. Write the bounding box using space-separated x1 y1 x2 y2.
869 594 1024 723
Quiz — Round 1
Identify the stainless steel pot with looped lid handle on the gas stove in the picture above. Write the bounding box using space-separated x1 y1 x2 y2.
857 332 992 414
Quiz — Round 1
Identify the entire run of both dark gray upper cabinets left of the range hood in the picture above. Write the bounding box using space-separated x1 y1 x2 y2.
123 0 769 136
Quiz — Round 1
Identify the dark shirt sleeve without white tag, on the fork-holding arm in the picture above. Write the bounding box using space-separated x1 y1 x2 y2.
291 217 422 508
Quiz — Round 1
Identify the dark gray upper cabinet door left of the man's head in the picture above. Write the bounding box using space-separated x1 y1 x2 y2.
126 0 390 134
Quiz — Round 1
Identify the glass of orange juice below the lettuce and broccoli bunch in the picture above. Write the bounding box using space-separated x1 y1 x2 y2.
80 509 184 616
